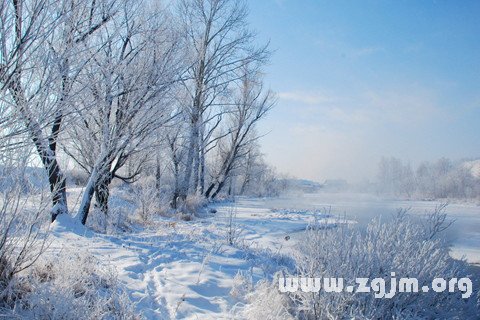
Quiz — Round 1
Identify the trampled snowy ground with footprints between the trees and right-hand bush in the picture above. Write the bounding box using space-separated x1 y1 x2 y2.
50 199 336 319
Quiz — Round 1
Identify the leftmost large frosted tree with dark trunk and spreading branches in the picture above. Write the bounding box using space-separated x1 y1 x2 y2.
0 0 120 220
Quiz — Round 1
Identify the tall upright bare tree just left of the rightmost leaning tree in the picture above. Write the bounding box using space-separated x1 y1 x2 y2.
178 0 268 199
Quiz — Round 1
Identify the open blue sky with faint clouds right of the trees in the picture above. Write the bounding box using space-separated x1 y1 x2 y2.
248 0 480 181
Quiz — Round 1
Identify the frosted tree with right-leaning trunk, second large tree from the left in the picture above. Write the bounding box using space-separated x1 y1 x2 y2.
65 1 179 223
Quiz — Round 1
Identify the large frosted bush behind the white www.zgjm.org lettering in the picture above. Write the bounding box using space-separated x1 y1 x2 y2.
247 211 479 319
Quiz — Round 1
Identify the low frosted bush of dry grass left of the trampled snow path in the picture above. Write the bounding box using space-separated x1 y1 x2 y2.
14 252 138 320
